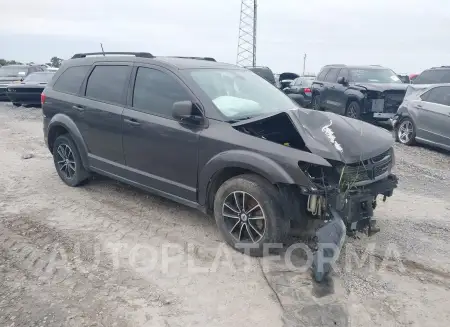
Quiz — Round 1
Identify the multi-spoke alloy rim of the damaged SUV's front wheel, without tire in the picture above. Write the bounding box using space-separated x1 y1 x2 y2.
222 191 266 243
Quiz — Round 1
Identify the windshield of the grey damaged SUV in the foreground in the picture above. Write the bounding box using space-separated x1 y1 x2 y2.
190 69 296 120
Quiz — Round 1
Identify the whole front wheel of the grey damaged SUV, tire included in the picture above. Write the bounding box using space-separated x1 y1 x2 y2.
214 174 290 257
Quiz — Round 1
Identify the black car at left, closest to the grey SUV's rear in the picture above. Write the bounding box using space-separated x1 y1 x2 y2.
6 72 55 106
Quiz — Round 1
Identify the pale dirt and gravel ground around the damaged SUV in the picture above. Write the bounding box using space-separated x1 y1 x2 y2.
0 103 450 327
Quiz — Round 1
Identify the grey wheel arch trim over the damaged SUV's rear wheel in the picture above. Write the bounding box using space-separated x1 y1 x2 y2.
47 114 89 169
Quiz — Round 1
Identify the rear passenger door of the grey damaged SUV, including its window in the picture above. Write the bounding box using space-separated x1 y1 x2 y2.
78 62 132 169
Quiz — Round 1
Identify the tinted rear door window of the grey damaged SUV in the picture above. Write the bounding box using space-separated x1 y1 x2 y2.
86 65 131 104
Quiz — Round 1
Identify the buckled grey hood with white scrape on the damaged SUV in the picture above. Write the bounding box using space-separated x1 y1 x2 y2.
286 108 394 164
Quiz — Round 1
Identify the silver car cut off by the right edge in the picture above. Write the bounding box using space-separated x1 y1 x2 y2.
392 84 450 150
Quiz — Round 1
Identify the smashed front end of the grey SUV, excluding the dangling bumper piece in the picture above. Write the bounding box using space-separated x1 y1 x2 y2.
300 148 398 234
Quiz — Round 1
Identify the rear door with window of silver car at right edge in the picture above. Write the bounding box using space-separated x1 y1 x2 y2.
417 86 450 146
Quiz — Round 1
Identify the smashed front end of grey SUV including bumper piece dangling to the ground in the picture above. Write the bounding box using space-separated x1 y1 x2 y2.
292 148 398 282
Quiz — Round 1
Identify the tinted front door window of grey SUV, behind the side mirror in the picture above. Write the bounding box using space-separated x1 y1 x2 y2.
133 67 191 117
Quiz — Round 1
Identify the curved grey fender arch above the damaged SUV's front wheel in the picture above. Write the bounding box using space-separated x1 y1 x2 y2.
198 150 310 205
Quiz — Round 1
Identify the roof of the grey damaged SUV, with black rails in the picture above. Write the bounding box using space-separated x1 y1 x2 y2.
64 55 243 69
